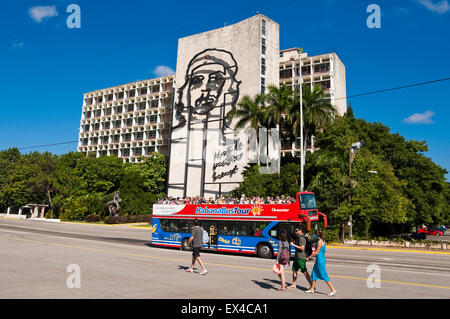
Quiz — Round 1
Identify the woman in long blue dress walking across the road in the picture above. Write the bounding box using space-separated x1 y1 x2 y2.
305 230 336 297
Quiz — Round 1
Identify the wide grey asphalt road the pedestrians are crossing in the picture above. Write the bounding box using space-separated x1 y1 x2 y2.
0 219 450 300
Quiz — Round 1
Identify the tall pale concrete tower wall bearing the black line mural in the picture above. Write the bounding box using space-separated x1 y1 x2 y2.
168 14 279 197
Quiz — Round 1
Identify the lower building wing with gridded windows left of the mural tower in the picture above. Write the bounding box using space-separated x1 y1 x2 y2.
78 75 175 163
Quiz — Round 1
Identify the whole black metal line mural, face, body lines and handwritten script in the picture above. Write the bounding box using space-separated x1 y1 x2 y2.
172 48 242 196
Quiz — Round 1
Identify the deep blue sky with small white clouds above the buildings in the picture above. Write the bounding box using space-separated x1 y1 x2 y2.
0 0 450 180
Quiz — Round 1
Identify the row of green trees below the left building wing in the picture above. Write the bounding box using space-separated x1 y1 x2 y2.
0 148 166 220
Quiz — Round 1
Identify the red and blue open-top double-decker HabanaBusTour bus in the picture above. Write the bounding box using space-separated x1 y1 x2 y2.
152 191 327 258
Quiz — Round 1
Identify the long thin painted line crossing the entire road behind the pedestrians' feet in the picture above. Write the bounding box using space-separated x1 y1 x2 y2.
0 236 450 290
